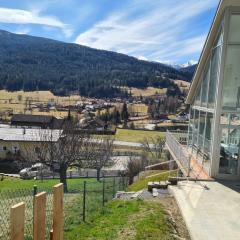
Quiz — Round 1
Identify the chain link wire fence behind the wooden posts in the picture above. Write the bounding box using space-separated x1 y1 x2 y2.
0 177 128 240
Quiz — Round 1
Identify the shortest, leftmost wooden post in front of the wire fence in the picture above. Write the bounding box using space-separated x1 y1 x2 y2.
10 202 25 240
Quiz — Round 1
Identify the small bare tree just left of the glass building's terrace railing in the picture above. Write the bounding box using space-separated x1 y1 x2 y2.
141 137 165 162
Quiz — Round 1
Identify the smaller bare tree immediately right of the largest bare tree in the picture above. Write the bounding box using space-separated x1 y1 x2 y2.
84 136 114 181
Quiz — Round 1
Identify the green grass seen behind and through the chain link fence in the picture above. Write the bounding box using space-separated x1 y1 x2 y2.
0 178 124 240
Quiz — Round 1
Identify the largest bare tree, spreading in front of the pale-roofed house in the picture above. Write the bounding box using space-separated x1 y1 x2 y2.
22 121 92 191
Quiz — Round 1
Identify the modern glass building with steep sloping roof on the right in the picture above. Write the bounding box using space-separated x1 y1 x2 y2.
167 0 240 179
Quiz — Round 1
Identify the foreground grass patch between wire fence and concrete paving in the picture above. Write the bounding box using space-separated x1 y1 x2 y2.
64 200 174 240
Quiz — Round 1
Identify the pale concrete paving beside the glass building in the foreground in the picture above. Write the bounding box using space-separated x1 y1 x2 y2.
169 181 240 240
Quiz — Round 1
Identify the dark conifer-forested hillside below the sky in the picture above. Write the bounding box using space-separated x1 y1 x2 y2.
0 30 195 97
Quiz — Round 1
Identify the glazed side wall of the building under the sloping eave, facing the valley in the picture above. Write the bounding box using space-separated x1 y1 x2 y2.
188 19 223 159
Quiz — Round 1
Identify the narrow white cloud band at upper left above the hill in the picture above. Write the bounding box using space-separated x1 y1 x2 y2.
0 7 72 37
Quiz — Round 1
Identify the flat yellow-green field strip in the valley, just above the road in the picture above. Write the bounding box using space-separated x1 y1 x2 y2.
115 129 165 142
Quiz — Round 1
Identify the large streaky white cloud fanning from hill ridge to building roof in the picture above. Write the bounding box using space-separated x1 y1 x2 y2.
75 0 218 61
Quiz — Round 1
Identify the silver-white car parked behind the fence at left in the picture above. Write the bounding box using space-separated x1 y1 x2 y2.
19 163 52 179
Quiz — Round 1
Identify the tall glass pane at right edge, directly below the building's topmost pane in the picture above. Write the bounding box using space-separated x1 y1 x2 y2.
222 45 240 110
